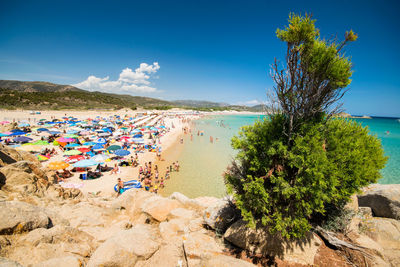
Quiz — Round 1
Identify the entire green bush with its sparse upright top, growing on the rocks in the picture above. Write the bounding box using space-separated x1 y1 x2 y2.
225 14 386 241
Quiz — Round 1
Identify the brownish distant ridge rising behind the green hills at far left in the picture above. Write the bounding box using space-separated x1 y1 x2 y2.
0 80 84 92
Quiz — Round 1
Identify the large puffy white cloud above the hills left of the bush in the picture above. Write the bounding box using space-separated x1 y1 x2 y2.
73 62 160 94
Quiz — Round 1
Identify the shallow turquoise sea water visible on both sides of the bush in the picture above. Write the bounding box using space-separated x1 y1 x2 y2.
162 115 400 198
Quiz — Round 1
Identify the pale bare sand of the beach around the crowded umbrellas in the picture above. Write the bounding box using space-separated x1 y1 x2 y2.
0 110 195 199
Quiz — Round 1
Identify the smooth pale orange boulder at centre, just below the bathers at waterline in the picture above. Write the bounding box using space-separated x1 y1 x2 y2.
142 196 181 222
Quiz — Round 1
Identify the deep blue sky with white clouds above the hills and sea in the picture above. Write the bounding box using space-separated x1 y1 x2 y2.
0 0 400 117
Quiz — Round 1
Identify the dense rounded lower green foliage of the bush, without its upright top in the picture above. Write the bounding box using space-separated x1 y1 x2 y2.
225 115 386 238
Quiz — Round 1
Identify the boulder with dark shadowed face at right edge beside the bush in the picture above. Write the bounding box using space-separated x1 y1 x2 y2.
358 184 400 220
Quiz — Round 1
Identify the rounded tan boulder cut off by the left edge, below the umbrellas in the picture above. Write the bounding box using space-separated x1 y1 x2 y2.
0 201 52 234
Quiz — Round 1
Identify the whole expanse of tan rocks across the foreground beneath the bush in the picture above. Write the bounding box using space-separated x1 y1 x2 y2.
0 145 400 267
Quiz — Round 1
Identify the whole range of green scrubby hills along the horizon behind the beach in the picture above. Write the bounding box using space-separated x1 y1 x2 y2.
0 80 262 111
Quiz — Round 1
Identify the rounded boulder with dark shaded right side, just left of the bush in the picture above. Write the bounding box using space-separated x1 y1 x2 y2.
203 199 240 233
